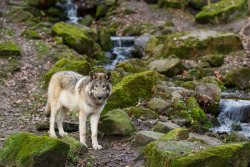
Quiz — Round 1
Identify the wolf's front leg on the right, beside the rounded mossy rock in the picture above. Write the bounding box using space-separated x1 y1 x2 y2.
90 113 102 150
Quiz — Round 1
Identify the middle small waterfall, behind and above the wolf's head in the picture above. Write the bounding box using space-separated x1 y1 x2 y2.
103 37 135 70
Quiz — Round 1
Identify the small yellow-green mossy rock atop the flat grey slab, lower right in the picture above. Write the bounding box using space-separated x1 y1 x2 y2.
159 128 189 140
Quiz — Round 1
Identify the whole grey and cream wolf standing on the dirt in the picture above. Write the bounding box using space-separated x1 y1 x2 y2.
45 71 112 150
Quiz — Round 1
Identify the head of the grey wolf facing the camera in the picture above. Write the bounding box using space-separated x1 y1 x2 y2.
88 71 112 104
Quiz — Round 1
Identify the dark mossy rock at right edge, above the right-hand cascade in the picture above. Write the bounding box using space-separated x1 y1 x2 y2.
223 67 250 89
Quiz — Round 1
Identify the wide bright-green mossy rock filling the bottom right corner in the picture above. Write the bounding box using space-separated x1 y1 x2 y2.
169 142 250 167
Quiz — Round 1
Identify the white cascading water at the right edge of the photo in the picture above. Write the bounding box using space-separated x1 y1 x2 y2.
211 99 250 138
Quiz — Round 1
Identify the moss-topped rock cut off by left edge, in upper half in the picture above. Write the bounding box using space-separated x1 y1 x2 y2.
0 42 21 57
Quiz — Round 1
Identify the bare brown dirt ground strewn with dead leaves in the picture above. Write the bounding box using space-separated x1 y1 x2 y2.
0 0 250 167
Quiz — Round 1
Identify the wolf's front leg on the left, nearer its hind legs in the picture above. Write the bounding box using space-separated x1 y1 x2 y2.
79 110 88 146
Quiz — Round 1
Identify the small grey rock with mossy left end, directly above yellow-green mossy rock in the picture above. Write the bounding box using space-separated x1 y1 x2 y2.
153 122 180 134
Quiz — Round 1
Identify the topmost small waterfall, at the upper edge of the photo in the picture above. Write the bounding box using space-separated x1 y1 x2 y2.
65 0 78 23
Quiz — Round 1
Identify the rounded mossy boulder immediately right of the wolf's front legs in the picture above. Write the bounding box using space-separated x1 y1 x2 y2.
98 109 135 136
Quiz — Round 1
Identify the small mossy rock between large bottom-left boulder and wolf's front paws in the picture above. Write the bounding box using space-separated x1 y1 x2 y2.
62 135 88 154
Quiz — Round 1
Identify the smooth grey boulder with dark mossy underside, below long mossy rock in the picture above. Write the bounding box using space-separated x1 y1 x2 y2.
149 56 183 77
